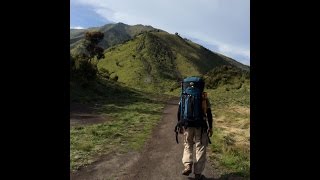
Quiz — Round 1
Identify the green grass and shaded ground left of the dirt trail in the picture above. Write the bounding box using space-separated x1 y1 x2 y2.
70 78 170 171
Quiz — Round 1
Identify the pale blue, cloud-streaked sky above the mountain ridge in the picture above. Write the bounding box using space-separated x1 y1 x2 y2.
70 0 250 65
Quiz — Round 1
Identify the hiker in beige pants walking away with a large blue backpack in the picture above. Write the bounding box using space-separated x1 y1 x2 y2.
176 77 212 179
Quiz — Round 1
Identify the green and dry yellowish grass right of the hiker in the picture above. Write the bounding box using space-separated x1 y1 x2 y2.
207 81 250 179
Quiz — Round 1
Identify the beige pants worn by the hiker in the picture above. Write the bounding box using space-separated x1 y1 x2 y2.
182 127 208 174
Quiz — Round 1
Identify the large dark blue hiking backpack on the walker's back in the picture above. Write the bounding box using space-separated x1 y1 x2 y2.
180 77 206 124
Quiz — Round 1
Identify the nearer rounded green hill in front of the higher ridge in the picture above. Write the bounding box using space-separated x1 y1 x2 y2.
98 32 246 93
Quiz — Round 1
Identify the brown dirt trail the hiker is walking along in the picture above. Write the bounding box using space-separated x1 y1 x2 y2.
71 99 214 180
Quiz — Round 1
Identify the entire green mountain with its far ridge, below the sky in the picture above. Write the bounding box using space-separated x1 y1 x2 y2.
70 23 250 92
